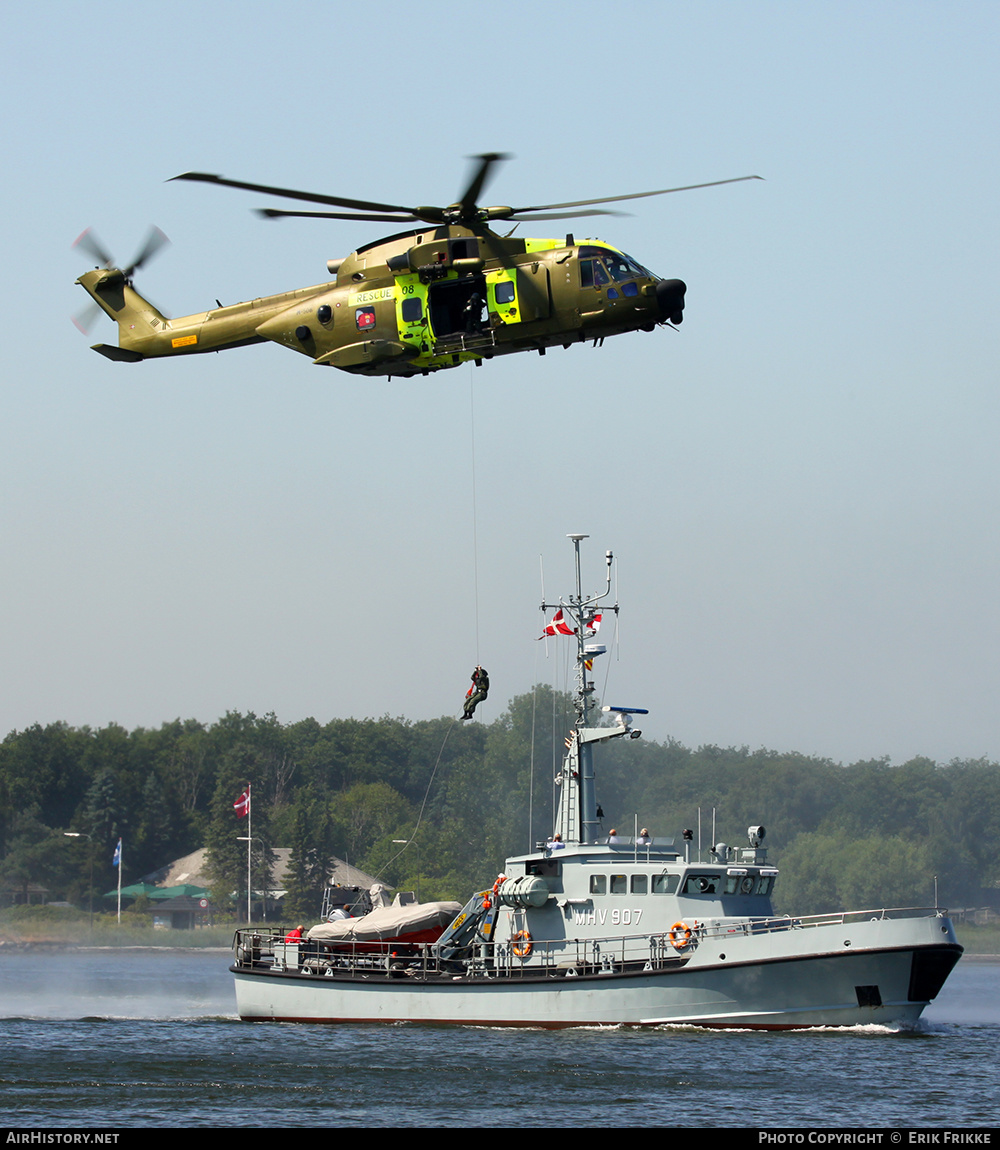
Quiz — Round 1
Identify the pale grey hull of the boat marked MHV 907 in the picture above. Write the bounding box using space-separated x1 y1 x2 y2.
232 919 962 1029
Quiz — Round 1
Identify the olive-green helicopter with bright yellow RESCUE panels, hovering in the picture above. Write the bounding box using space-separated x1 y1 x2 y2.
76 152 762 377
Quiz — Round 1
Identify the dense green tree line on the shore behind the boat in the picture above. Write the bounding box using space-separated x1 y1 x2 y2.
0 687 1000 917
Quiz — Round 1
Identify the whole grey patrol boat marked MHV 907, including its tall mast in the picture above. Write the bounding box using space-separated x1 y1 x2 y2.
231 535 962 1029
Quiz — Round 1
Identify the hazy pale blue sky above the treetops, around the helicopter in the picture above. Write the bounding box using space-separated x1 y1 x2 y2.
0 0 1000 762
